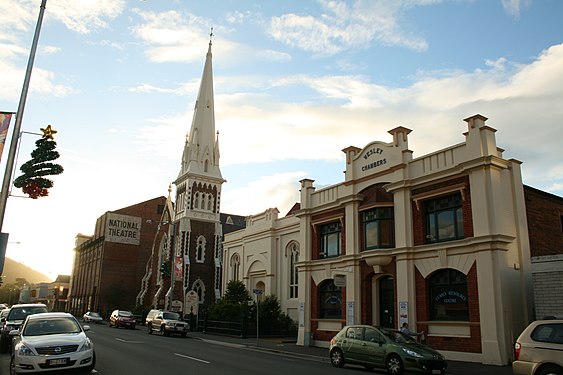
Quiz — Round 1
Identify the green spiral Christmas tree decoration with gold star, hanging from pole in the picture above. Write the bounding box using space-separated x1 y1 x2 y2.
14 125 64 199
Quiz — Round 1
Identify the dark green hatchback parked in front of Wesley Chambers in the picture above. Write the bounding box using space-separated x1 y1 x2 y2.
329 325 447 375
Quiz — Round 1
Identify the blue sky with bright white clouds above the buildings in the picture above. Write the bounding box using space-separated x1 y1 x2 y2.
0 0 563 279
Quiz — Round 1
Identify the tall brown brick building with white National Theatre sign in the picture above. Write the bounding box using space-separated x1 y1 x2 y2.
67 197 166 317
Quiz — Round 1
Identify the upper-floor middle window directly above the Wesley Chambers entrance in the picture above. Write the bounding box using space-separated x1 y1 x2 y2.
362 207 395 250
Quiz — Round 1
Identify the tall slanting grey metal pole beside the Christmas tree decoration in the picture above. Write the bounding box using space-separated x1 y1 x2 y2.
0 0 47 231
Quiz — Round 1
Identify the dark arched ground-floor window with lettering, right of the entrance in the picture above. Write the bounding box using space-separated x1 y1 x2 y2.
428 269 469 321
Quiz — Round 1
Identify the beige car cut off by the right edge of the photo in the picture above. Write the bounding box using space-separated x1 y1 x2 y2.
512 319 563 375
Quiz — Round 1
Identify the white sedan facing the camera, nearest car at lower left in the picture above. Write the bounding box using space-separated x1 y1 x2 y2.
10 313 96 374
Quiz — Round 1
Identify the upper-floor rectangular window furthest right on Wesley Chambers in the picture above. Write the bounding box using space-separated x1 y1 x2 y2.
425 193 463 243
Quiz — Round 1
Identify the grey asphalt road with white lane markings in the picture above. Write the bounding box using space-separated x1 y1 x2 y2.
0 325 344 375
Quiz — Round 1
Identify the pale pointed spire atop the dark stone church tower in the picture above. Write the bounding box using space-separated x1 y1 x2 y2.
178 34 222 180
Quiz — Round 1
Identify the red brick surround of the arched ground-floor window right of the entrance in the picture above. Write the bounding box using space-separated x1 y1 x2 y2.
415 264 482 353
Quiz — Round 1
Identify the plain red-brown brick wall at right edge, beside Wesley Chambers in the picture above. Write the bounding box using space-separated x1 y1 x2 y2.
524 186 563 257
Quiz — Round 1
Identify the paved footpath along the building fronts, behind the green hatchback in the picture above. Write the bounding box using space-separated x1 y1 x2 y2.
188 332 512 375
